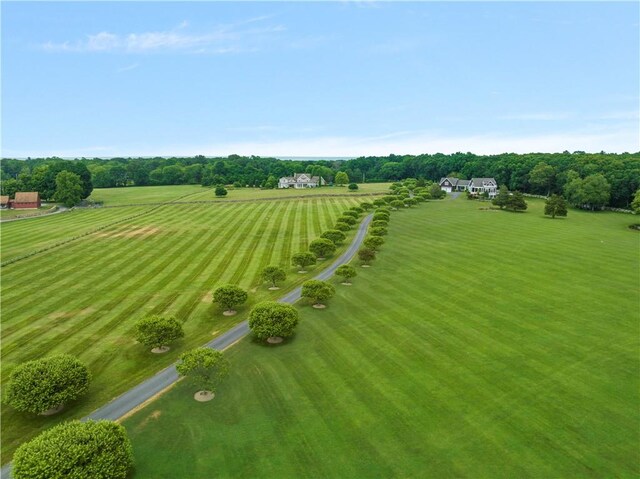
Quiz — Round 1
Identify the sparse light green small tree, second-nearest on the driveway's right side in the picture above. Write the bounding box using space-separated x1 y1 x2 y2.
176 348 229 396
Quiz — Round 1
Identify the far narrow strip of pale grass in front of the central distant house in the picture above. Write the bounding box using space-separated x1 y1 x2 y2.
90 183 390 206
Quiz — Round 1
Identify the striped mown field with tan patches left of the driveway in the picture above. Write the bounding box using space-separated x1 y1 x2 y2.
1 197 368 463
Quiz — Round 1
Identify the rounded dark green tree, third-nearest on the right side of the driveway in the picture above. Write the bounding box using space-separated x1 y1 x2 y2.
249 301 299 342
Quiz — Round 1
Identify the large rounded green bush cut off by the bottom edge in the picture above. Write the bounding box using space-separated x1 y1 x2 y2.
11 421 133 479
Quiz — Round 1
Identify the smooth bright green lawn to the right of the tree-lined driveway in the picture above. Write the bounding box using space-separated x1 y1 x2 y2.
124 199 640 478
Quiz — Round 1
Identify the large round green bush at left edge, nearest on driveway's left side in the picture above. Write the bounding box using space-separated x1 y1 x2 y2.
4 354 91 414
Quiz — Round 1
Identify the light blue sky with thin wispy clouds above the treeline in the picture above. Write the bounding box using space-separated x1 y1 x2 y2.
2 2 640 157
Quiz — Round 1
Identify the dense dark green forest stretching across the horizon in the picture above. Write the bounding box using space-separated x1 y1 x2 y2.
0 151 640 208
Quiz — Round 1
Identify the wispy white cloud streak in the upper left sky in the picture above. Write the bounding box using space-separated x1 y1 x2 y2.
41 17 285 54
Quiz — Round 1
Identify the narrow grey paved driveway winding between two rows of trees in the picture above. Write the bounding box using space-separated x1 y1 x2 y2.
0 214 373 479
